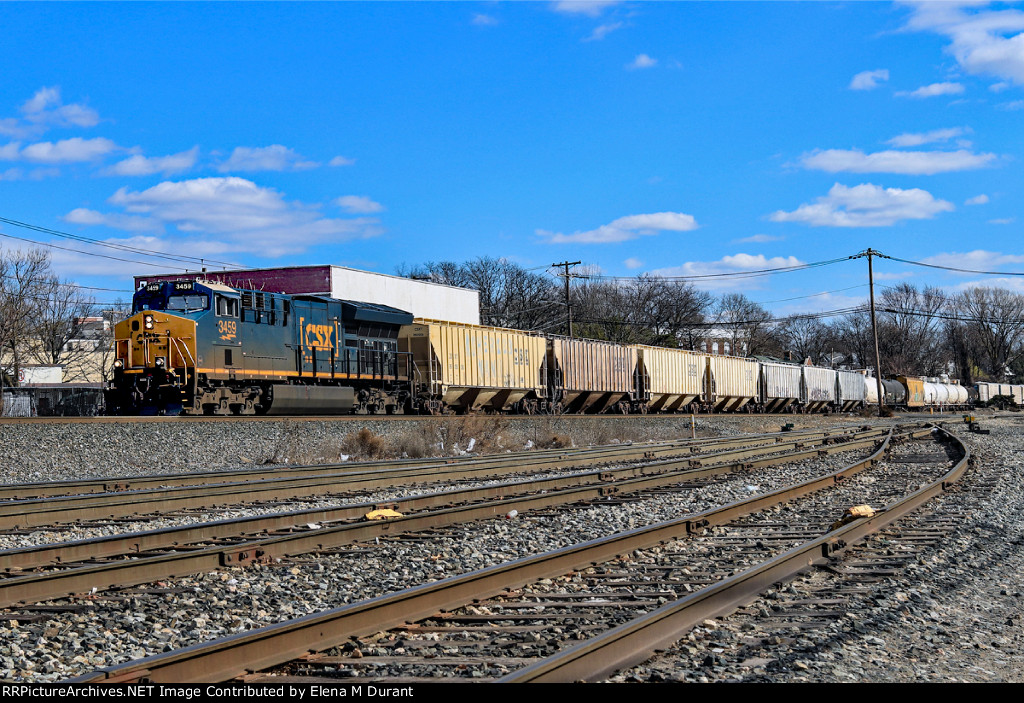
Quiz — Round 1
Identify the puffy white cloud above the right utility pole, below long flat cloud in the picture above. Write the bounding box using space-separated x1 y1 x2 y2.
770 183 954 227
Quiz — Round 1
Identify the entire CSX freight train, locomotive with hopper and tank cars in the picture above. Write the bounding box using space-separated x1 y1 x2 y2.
106 280 968 414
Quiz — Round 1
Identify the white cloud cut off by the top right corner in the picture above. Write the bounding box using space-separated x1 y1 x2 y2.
907 2 1024 85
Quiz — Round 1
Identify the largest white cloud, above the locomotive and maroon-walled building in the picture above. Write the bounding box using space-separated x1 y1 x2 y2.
103 176 383 257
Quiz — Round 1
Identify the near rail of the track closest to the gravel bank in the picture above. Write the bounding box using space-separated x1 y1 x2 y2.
0 423 897 529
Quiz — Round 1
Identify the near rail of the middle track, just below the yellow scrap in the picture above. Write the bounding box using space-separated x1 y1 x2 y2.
0 429 877 607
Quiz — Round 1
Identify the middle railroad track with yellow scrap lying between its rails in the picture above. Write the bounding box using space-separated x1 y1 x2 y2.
0 423 892 607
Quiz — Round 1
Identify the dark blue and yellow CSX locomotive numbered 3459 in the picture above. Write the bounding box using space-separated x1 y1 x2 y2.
106 280 413 414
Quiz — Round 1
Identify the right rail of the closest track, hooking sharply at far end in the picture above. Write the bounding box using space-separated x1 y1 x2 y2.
499 428 973 683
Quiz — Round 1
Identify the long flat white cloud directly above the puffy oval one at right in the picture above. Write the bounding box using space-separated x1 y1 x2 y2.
801 149 996 175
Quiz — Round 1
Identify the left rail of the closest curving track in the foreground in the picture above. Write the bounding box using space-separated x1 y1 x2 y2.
72 423 927 683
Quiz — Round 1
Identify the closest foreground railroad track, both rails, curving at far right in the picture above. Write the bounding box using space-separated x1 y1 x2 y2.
66 423 967 682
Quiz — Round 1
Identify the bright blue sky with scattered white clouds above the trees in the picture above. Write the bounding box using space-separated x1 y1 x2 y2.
0 2 1024 314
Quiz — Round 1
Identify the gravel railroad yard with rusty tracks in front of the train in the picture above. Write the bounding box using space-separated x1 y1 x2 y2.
0 414 1024 684
